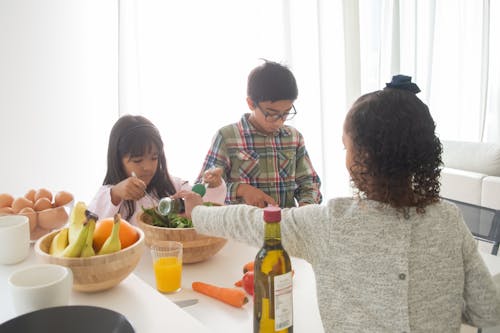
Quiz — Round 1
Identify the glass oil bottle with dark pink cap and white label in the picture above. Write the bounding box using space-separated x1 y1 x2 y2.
253 207 293 333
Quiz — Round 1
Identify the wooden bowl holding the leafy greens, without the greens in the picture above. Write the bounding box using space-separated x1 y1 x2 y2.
137 213 227 264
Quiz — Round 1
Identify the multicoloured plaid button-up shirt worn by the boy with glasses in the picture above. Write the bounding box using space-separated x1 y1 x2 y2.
197 113 322 208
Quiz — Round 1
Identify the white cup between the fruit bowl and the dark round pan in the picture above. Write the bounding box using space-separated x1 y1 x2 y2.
9 264 73 315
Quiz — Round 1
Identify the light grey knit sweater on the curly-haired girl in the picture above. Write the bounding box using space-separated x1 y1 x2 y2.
192 198 500 332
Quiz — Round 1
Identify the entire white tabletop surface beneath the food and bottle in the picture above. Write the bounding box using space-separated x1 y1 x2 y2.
0 241 500 333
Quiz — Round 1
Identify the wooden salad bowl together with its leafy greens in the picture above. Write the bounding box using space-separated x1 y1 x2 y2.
137 208 227 264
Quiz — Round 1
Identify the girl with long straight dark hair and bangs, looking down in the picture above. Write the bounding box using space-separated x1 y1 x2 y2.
88 115 226 224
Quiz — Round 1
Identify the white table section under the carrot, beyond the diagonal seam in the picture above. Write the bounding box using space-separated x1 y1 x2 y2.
134 241 324 333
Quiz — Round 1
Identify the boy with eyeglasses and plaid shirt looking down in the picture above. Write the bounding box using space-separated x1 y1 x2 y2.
198 60 322 208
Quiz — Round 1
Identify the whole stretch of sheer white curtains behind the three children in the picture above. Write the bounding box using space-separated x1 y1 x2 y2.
119 0 500 198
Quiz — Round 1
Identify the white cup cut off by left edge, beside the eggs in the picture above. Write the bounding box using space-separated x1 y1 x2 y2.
0 215 30 265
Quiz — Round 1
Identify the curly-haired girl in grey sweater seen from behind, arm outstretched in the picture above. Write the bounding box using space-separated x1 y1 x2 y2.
176 76 500 333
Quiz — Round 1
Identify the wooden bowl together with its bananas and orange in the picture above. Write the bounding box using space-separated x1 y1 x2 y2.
35 203 145 292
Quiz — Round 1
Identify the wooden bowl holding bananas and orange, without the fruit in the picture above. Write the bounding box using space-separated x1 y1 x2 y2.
35 227 144 292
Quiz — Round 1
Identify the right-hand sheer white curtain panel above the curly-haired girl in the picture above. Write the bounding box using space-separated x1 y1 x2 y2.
359 0 500 142
